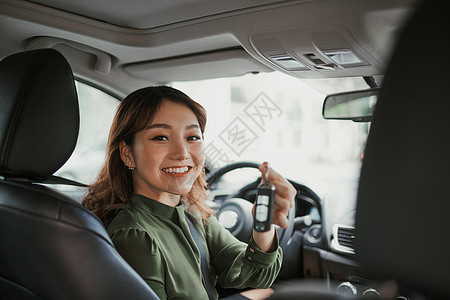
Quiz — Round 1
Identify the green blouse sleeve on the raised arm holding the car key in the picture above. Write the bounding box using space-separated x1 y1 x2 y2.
206 217 283 288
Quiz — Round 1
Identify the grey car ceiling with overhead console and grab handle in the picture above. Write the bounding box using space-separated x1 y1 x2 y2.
0 0 416 96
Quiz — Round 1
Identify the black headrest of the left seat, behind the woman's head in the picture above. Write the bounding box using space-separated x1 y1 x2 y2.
0 49 80 180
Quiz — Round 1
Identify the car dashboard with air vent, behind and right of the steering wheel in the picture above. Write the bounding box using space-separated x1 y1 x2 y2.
209 166 424 299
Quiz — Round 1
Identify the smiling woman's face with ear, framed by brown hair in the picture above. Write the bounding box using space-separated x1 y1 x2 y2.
121 101 204 205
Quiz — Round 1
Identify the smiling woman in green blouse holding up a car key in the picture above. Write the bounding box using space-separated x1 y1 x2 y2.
83 86 296 299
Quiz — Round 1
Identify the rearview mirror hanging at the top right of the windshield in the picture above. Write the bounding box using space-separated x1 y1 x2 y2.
322 88 380 122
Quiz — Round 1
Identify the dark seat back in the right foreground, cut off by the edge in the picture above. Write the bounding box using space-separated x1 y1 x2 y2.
355 1 450 298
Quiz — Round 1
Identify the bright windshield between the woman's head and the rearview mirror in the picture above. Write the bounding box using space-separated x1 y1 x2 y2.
172 72 368 195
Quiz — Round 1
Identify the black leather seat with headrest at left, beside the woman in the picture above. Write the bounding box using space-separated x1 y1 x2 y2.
0 49 157 299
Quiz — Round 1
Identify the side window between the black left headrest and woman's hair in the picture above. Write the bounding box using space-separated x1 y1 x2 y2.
55 82 119 186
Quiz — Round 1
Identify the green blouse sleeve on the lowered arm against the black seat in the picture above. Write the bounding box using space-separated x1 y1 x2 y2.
110 228 167 299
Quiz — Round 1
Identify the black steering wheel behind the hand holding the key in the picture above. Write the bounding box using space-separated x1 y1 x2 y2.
205 162 296 248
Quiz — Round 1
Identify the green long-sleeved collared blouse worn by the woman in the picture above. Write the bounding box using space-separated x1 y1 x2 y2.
107 195 283 300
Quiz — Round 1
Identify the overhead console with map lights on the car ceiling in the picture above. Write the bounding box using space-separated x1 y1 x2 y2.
250 25 384 78
